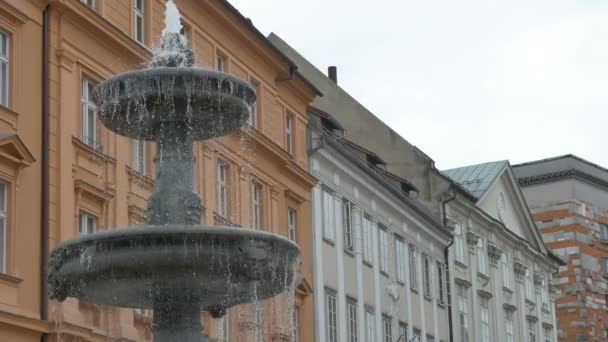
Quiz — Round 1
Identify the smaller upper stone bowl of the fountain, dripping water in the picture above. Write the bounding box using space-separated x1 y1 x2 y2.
93 66 256 141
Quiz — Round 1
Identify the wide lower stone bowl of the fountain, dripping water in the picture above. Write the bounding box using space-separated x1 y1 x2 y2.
49 225 300 315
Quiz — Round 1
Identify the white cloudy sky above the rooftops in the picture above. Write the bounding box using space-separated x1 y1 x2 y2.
230 0 608 169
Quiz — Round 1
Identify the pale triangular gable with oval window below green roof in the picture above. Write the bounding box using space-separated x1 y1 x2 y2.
477 166 545 252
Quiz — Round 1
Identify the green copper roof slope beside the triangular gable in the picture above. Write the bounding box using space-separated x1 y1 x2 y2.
442 160 509 199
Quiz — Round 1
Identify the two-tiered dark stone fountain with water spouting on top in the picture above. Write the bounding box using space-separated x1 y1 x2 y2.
49 0 299 342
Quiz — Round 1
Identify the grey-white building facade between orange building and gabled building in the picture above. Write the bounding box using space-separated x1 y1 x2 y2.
310 114 451 342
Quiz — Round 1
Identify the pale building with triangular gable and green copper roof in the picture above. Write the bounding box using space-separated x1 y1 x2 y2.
444 161 559 342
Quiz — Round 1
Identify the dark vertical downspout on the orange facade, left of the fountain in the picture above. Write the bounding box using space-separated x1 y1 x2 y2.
40 5 50 342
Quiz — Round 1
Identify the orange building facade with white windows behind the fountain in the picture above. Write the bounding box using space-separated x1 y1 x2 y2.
0 0 318 342
